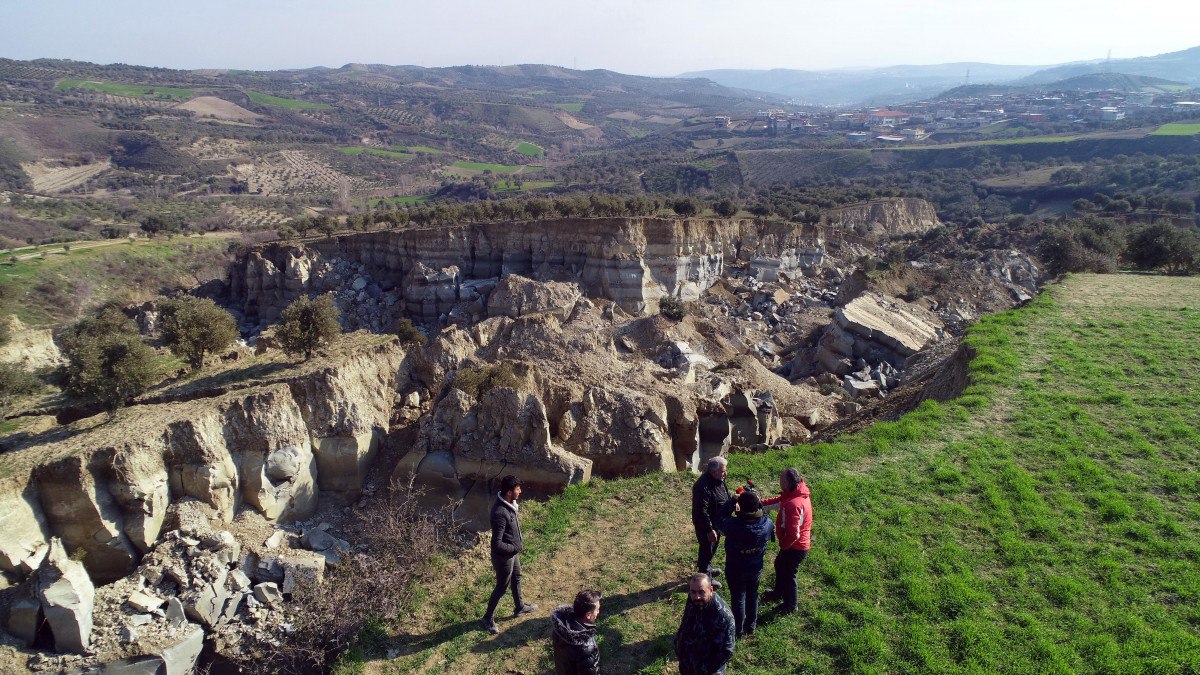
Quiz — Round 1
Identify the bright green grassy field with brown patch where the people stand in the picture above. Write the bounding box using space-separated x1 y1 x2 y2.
366 275 1200 673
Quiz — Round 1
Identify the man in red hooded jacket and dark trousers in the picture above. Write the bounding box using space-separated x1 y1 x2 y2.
762 468 812 614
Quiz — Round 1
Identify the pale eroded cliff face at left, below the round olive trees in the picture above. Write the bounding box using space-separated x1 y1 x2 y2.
0 339 404 583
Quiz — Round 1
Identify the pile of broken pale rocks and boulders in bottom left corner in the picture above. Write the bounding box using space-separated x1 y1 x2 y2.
0 500 352 675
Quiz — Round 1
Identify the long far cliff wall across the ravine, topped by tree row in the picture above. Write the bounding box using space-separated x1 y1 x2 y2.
223 207 937 327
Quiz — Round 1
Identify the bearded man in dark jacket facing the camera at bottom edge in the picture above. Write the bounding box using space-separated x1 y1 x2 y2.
674 572 733 675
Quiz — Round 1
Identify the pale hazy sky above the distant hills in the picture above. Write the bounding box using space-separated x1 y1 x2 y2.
0 0 1200 76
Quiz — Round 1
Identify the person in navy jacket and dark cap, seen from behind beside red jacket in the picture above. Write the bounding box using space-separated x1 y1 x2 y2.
718 490 772 638
